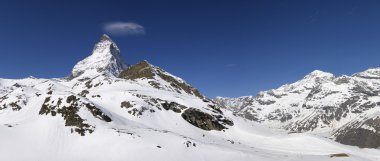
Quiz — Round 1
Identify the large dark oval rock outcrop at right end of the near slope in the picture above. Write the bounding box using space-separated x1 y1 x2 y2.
182 108 233 131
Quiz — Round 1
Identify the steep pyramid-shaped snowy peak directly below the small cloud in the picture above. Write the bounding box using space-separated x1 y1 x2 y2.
72 34 127 77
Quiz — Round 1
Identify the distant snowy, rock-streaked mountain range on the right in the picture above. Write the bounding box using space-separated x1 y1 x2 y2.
215 68 380 148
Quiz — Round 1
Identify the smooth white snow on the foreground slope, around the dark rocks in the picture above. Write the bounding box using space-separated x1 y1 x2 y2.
0 77 380 161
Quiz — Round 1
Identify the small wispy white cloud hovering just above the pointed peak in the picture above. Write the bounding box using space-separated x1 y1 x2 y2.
103 22 145 36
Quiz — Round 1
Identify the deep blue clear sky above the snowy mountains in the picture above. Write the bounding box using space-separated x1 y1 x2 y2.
0 0 380 97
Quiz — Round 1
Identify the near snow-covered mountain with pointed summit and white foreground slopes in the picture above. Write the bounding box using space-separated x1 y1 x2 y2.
0 35 380 161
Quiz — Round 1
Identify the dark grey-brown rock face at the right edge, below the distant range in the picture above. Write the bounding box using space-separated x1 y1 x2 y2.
335 117 380 148
